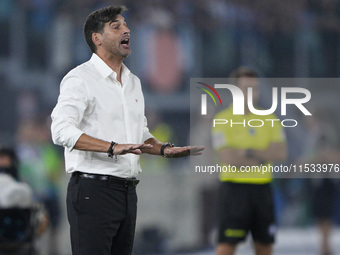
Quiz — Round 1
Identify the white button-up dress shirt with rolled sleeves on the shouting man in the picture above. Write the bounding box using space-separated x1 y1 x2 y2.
51 54 153 178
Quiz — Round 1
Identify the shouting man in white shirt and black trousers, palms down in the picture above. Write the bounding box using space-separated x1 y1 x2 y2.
51 6 203 255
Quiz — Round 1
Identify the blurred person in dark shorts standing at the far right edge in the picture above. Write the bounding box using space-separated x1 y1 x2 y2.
297 112 340 255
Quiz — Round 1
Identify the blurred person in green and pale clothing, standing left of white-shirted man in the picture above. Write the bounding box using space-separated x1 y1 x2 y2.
18 117 63 255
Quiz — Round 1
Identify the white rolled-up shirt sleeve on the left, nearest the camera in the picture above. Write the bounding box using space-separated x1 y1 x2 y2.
51 76 89 150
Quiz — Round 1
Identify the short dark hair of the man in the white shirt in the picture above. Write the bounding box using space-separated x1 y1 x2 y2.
84 6 127 53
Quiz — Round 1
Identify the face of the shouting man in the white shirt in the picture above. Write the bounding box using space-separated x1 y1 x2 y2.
101 15 131 59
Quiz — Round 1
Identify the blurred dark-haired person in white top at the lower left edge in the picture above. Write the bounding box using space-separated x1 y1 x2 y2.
0 148 49 255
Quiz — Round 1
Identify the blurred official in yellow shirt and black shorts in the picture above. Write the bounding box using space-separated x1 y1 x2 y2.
212 67 287 255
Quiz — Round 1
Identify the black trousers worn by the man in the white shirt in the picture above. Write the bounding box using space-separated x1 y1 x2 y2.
66 175 137 255
